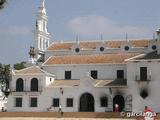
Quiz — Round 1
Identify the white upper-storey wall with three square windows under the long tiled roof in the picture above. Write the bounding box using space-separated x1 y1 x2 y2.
44 64 127 80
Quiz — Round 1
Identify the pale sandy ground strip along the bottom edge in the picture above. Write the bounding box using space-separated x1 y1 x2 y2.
0 117 134 120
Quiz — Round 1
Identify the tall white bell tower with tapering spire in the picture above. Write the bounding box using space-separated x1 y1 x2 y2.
34 0 50 61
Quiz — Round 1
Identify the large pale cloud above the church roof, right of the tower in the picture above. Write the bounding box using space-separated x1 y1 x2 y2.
67 15 152 38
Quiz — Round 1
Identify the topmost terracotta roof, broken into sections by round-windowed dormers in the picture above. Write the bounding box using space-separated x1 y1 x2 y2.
47 40 149 50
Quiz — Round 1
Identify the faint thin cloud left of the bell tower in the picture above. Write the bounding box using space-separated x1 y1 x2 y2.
0 26 31 35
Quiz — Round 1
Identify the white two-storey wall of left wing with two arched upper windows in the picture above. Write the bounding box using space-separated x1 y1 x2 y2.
7 75 54 111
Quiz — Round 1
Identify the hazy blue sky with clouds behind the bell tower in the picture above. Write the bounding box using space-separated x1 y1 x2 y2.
0 0 160 64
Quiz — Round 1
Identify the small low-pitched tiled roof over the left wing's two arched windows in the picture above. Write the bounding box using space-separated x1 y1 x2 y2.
14 66 54 76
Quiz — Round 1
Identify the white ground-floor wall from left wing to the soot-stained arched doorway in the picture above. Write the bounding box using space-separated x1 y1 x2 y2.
8 77 130 112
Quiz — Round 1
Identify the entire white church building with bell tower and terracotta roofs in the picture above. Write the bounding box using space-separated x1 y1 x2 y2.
7 0 160 112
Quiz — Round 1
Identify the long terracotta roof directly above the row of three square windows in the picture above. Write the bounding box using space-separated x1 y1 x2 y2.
44 53 138 65
